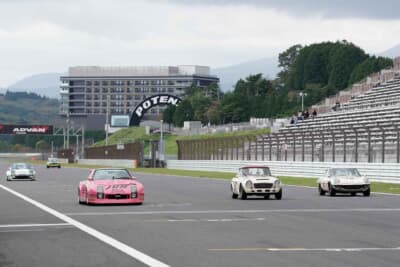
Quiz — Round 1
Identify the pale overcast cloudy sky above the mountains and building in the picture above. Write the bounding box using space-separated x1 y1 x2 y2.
0 0 400 87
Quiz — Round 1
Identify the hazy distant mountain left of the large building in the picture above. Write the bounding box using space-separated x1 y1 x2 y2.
0 73 63 98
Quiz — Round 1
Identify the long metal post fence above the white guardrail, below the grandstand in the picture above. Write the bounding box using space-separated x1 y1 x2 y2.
177 127 400 163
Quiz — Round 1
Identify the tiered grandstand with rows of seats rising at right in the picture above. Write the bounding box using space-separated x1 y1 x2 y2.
255 58 400 163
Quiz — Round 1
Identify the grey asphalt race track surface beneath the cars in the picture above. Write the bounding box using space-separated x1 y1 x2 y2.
0 162 400 267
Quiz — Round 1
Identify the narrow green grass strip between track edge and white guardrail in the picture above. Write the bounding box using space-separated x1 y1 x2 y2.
31 160 400 194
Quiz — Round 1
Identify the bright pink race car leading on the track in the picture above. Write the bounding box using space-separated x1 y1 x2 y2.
78 168 144 204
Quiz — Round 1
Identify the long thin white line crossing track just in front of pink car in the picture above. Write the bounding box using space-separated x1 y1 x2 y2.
65 208 400 216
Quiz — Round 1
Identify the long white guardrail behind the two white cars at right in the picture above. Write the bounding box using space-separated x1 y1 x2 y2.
167 160 400 183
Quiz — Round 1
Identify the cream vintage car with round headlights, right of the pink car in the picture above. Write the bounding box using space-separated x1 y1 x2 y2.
231 166 282 199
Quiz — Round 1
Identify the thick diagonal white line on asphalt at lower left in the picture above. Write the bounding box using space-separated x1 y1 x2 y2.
0 184 169 267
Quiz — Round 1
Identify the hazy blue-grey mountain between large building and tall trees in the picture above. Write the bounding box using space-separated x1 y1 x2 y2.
211 57 279 92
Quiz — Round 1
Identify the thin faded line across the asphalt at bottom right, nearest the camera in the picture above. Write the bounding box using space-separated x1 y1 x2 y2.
207 247 400 252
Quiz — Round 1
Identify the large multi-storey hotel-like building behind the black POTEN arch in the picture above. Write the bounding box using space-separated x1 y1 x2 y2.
60 65 219 129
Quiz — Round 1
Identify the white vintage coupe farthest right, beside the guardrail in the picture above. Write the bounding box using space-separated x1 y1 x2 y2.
317 168 371 196
